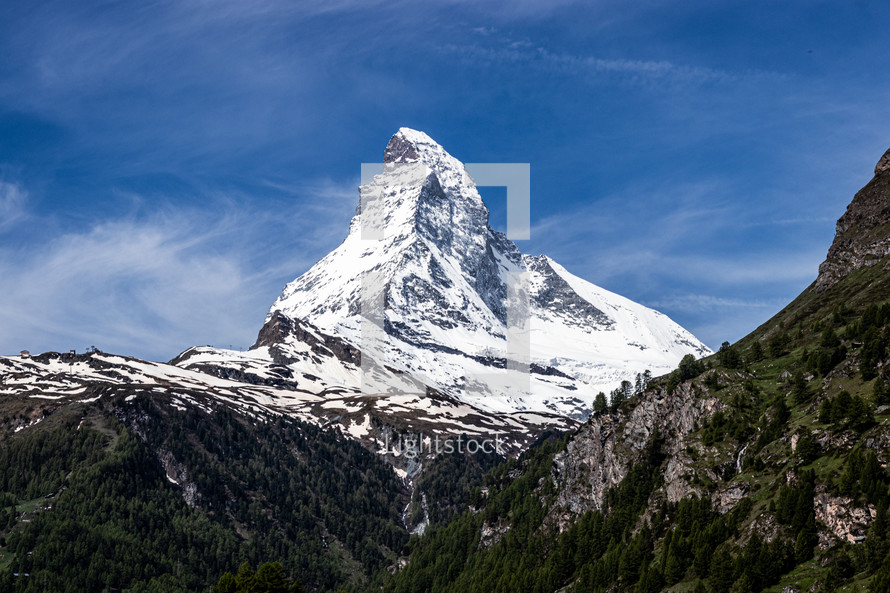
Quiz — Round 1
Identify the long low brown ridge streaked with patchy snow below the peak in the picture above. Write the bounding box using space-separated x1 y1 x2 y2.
0 347 564 460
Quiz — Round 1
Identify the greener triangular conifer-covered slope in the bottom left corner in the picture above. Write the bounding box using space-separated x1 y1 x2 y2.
2 429 240 593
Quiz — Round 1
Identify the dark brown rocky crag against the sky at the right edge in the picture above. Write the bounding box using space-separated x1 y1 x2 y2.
815 144 890 292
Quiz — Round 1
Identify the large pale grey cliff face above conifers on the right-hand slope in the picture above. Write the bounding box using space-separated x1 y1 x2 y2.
554 383 723 527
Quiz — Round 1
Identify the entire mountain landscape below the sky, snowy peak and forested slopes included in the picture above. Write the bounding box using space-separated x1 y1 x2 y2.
0 133 890 593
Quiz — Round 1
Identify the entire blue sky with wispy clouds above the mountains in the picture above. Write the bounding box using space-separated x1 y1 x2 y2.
0 0 890 360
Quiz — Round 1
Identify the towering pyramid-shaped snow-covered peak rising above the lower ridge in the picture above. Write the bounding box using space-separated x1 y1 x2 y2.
255 128 710 416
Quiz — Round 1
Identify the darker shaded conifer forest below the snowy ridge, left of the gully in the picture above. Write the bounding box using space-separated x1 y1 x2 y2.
125 400 408 590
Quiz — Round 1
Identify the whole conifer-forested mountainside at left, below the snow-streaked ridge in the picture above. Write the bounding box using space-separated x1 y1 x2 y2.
0 396 408 593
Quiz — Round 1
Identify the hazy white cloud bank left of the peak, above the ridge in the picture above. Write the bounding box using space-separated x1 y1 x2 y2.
0 177 355 360
